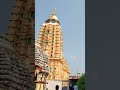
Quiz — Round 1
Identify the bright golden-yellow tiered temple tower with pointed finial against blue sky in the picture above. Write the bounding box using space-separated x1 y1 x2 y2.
38 9 70 81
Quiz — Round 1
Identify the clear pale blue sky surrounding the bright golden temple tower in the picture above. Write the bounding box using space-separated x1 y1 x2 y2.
35 0 85 75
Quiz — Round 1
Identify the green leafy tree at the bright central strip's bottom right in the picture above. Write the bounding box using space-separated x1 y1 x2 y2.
76 74 85 90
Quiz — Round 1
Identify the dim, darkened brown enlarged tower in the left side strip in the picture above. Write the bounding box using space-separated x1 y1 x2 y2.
6 0 35 76
